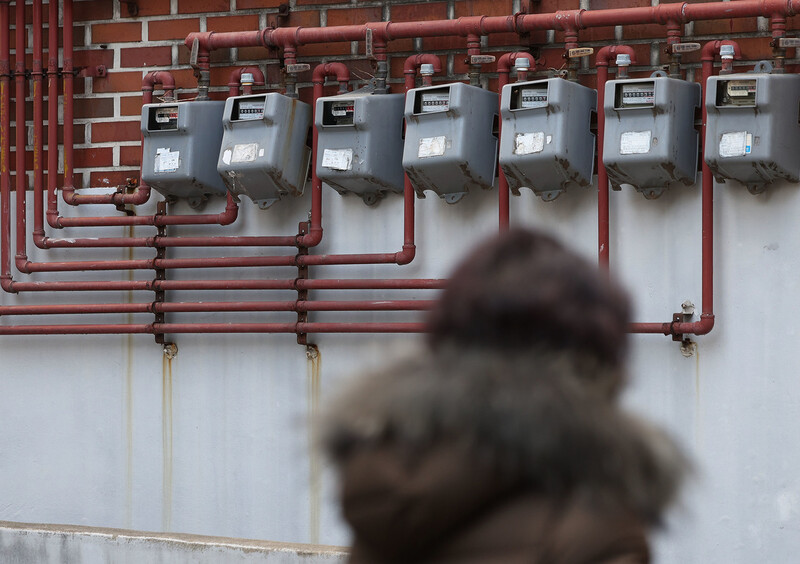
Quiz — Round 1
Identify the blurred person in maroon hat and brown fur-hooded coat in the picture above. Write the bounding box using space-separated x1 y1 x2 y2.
322 229 687 564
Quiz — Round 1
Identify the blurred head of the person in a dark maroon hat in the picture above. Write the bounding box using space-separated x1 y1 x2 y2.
428 228 630 367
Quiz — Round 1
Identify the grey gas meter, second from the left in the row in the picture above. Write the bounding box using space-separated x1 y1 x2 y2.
219 92 311 209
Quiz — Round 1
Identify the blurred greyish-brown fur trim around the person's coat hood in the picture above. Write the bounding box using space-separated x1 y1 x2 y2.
321 350 688 523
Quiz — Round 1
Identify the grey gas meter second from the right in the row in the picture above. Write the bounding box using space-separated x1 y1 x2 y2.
603 76 700 198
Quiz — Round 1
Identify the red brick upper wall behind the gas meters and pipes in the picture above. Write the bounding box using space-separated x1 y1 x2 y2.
48 0 795 186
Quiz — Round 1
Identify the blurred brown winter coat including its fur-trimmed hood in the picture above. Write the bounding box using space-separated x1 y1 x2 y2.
324 352 685 564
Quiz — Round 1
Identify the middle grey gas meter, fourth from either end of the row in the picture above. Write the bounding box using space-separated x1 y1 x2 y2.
403 82 497 203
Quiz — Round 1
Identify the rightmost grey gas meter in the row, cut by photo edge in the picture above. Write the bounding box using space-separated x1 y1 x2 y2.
705 73 800 193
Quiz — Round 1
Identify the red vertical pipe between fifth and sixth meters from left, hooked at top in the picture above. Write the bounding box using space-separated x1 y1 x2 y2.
594 45 636 270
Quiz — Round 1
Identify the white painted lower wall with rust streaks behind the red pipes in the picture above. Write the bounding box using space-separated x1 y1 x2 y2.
0 175 800 564
